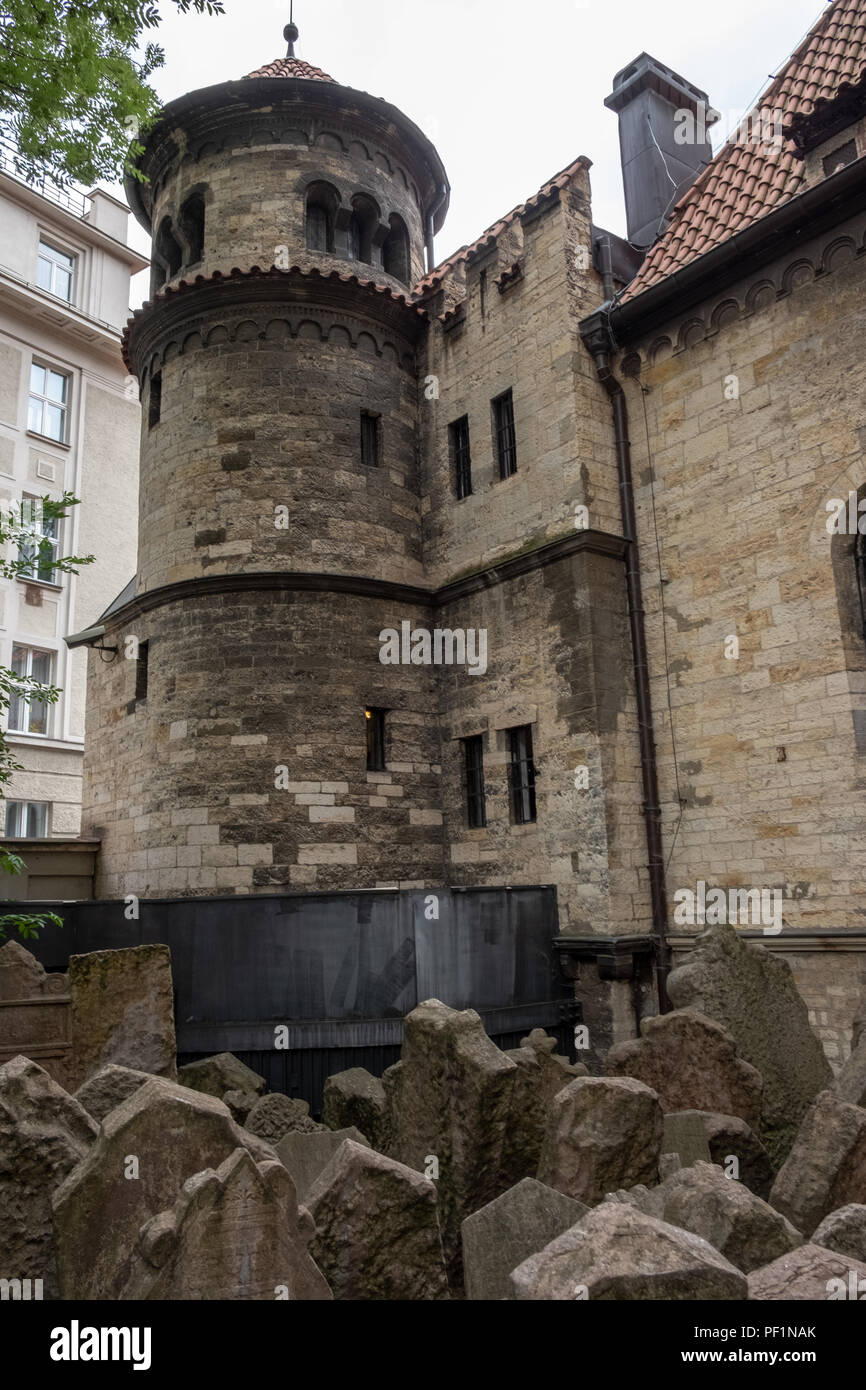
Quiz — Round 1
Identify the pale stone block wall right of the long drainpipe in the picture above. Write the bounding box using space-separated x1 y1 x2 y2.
620 208 866 934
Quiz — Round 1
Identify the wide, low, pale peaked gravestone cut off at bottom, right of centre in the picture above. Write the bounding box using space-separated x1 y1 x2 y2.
512 1202 746 1302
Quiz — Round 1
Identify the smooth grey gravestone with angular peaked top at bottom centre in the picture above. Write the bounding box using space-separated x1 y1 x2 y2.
461 1177 589 1302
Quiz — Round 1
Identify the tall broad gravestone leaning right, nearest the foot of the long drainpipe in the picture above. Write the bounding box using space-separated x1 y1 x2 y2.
667 924 833 1169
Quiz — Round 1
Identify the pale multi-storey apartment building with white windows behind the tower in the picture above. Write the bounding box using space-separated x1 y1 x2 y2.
0 145 147 834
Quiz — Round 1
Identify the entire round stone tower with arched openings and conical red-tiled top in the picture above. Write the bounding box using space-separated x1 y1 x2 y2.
85 35 449 897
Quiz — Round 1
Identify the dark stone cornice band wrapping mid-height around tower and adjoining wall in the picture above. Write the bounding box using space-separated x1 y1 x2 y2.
86 531 627 641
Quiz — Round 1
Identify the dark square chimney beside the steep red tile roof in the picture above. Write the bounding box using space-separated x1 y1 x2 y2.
605 53 719 249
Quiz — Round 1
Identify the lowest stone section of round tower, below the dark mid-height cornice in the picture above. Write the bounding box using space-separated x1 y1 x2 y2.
85 591 443 897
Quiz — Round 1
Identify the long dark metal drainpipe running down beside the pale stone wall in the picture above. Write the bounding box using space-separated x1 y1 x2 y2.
594 350 670 1013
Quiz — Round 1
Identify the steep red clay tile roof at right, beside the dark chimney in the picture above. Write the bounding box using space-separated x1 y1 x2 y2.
621 0 866 303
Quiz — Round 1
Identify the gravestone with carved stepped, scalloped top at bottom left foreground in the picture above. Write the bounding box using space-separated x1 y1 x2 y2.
126 1148 332 1301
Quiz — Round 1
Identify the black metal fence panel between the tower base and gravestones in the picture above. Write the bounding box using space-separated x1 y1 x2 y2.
22 887 575 1111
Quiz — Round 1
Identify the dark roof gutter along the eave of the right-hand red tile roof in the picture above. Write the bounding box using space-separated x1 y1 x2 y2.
606 157 866 346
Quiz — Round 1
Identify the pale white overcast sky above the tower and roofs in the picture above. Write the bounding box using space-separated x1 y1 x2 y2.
122 0 823 302
